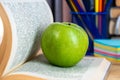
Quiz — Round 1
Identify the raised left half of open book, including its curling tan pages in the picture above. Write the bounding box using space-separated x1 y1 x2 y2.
0 0 53 79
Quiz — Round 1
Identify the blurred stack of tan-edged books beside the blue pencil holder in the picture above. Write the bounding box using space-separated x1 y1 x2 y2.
109 0 120 38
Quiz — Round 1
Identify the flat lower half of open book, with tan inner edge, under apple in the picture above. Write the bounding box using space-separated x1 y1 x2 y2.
2 54 110 80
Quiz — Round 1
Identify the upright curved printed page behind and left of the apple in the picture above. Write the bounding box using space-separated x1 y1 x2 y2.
1 0 53 73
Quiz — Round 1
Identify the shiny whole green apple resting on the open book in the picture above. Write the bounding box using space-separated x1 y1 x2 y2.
41 22 89 67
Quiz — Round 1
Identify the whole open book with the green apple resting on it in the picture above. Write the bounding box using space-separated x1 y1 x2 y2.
0 0 110 80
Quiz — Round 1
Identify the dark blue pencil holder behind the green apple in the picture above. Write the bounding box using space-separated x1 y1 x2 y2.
71 12 109 55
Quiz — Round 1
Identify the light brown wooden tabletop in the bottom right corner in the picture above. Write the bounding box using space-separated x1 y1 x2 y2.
106 64 120 80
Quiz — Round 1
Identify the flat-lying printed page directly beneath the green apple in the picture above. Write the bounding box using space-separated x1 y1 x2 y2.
9 55 110 80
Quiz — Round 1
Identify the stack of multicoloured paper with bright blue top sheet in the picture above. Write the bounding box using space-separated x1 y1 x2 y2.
94 39 120 63
